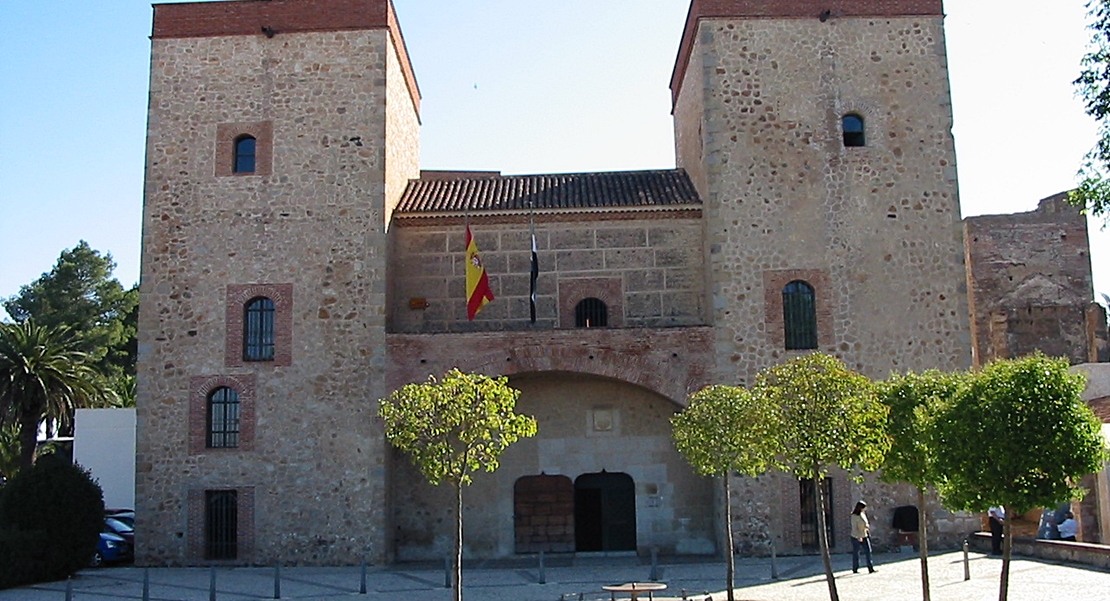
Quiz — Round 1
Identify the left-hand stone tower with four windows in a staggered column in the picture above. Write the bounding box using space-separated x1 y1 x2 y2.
137 0 420 564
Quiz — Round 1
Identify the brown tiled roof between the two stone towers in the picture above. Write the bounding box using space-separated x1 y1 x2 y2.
395 169 702 217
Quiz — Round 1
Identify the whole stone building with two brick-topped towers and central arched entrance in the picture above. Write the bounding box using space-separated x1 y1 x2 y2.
137 0 1025 564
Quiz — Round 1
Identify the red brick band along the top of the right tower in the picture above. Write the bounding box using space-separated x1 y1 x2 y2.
670 0 945 106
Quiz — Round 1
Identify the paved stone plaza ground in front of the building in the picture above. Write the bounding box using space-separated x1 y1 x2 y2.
0 552 1110 601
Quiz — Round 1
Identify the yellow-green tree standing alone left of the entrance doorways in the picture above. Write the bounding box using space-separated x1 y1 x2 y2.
379 369 536 601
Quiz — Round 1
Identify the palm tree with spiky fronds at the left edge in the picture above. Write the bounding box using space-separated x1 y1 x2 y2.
0 319 114 469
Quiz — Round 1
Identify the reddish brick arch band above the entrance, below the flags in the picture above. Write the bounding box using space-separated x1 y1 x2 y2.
387 328 715 407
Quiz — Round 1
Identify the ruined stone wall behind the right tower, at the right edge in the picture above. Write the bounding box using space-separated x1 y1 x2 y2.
965 192 1108 364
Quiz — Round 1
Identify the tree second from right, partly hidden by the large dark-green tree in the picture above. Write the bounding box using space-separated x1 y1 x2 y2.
879 371 961 601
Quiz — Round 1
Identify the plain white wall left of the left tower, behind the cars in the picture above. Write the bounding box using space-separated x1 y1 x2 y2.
73 409 135 509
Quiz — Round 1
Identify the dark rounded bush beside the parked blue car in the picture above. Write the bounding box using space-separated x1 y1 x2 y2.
0 455 104 589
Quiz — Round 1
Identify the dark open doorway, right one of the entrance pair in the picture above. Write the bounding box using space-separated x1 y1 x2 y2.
574 471 636 551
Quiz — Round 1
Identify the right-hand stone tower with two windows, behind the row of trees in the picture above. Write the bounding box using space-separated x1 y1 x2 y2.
672 0 970 544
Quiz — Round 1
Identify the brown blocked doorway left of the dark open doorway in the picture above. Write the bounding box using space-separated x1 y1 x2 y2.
513 474 574 553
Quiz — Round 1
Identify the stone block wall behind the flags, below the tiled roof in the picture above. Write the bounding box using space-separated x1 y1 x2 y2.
390 212 706 333
